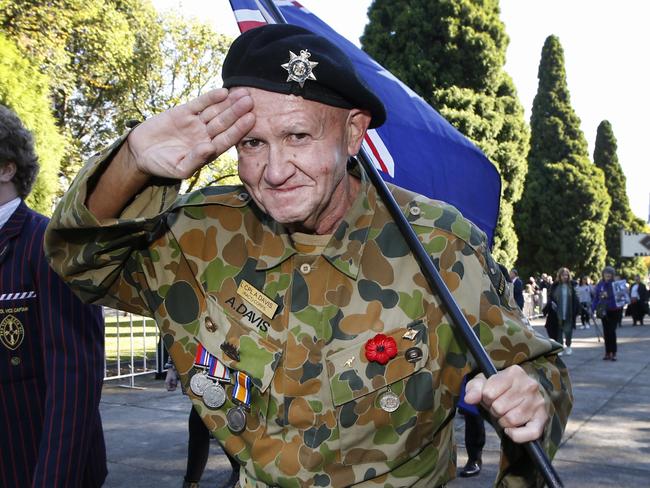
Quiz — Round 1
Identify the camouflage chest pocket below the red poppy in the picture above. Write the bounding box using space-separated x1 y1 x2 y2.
326 322 434 468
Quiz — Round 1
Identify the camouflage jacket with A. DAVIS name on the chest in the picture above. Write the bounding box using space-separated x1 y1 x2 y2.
46 141 572 487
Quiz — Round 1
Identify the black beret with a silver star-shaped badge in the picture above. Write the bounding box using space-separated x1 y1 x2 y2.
222 24 386 128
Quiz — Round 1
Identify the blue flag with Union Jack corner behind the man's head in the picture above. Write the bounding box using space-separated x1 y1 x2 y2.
225 0 501 245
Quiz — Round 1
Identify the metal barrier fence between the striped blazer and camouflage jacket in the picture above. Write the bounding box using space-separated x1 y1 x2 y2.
103 307 166 388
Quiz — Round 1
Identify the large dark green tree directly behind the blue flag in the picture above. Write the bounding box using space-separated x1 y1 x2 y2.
361 0 529 267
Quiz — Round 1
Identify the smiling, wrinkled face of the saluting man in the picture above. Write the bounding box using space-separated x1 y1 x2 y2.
236 88 365 233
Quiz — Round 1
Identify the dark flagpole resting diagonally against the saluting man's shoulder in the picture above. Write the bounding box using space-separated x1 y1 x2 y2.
263 0 564 488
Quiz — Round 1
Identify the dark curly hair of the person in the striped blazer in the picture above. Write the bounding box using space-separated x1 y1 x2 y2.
0 104 39 199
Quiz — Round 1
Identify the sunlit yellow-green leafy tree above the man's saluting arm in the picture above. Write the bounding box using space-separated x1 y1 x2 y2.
0 0 230 191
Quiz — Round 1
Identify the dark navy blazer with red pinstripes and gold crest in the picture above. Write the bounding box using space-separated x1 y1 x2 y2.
0 202 106 488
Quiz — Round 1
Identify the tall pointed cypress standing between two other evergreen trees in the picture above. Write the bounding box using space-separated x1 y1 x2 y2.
515 36 610 274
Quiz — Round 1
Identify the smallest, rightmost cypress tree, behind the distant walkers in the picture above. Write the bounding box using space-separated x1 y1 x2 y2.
594 120 645 278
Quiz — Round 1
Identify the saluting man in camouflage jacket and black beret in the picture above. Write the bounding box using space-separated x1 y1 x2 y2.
47 25 572 487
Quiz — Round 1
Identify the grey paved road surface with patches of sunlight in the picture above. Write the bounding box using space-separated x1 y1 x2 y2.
101 319 650 488
